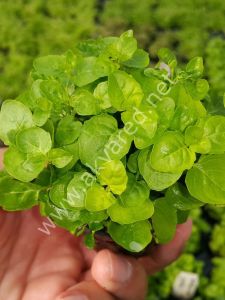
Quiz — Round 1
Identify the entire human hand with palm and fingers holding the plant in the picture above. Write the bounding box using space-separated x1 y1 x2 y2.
0 150 192 300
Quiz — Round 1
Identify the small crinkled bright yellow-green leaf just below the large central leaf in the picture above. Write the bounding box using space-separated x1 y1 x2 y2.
98 160 128 195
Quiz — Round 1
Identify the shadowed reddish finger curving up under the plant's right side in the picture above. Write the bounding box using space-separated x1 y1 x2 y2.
138 219 192 275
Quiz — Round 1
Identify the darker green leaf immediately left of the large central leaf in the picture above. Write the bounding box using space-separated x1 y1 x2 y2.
55 116 82 146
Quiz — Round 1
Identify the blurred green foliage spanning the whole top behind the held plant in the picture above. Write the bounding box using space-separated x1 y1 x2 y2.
0 0 225 108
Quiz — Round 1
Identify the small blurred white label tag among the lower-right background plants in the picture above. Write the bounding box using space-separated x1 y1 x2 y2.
173 272 199 300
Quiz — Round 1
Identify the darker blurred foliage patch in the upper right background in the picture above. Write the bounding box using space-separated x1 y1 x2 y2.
98 0 225 111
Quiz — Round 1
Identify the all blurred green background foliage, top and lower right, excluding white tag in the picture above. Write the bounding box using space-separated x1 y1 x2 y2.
0 0 225 300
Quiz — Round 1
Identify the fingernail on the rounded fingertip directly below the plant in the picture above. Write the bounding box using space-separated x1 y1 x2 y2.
108 252 133 283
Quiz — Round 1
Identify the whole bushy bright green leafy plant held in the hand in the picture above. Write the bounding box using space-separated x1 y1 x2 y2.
0 30 225 252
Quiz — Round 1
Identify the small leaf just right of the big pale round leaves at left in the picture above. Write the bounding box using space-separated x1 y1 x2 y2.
48 148 73 168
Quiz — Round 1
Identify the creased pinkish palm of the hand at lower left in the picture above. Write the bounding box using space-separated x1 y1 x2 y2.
0 209 94 300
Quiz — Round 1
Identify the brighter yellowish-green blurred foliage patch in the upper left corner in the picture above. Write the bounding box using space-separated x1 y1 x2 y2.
0 0 96 100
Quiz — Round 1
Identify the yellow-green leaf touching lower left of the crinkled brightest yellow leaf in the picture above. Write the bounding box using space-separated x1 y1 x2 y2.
85 183 116 212
